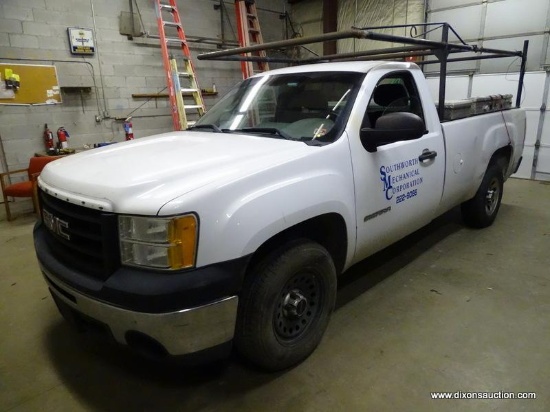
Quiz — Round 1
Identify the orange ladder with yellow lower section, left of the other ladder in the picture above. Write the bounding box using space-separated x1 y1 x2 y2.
154 0 205 130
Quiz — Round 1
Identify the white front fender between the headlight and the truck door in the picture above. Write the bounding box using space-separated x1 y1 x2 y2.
159 137 356 267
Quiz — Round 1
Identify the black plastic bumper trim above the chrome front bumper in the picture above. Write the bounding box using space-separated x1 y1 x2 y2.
34 224 249 313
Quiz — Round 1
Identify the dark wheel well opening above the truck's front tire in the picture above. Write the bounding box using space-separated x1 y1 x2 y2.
248 213 348 273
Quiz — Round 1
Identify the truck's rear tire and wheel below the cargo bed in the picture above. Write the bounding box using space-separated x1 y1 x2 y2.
461 162 504 228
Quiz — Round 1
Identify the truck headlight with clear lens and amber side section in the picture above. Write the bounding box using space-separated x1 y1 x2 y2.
118 215 197 270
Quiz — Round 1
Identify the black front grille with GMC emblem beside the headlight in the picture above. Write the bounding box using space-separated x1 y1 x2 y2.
39 190 120 279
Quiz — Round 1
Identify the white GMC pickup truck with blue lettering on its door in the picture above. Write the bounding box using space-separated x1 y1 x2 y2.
34 61 525 370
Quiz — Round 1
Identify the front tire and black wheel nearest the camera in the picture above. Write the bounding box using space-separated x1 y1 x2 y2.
235 240 336 371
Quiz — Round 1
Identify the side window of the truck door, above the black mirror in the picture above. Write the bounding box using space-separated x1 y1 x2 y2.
361 72 424 128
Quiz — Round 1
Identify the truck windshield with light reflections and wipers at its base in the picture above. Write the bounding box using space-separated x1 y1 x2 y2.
190 72 364 142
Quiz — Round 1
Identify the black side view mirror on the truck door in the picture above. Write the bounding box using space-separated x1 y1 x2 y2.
359 112 428 153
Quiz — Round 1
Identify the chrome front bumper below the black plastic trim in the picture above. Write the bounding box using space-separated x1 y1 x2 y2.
41 267 238 356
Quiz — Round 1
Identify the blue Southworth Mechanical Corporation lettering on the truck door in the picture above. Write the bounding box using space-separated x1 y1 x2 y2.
380 157 424 203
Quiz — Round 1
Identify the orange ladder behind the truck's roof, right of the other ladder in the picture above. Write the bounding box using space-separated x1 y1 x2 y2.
235 0 269 79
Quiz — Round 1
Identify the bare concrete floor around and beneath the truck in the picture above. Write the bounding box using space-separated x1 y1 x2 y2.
0 179 550 412
